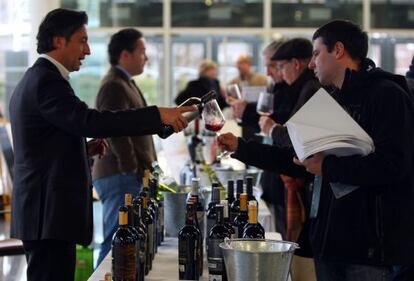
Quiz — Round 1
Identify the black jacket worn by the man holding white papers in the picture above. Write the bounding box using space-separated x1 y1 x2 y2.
235 60 414 265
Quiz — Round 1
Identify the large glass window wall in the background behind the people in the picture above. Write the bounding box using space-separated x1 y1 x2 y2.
0 0 414 117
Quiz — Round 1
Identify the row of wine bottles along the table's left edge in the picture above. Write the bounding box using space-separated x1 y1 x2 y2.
112 170 164 281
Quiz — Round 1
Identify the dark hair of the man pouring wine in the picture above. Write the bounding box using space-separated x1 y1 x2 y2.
36 8 88 54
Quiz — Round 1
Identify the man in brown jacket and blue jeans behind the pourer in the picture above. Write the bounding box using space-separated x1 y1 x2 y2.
92 28 157 264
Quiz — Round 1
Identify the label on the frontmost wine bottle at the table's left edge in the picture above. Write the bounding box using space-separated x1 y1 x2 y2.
112 244 136 280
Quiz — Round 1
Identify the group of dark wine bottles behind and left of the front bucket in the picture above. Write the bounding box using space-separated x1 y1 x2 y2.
178 177 265 281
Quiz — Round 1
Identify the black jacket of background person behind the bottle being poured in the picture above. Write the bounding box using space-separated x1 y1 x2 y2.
175 77 227 109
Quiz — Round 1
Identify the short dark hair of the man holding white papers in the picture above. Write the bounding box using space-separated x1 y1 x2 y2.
312 20 368 60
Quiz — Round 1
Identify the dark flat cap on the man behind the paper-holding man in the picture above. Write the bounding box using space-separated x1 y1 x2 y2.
272 38 312 60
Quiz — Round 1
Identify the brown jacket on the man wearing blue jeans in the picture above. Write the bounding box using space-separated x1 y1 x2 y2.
92 67 157 180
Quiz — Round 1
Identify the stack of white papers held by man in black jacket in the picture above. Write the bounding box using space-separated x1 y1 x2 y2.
286 88 374 161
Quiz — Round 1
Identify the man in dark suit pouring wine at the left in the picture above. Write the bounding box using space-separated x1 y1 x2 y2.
10 9 191 281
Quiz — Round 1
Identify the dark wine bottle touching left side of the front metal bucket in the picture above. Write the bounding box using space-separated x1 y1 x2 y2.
207 204 230 281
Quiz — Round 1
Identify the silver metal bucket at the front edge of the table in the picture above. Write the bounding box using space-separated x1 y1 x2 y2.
220 239 299 281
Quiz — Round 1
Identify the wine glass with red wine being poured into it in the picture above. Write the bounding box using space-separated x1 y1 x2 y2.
201 99 230 160
